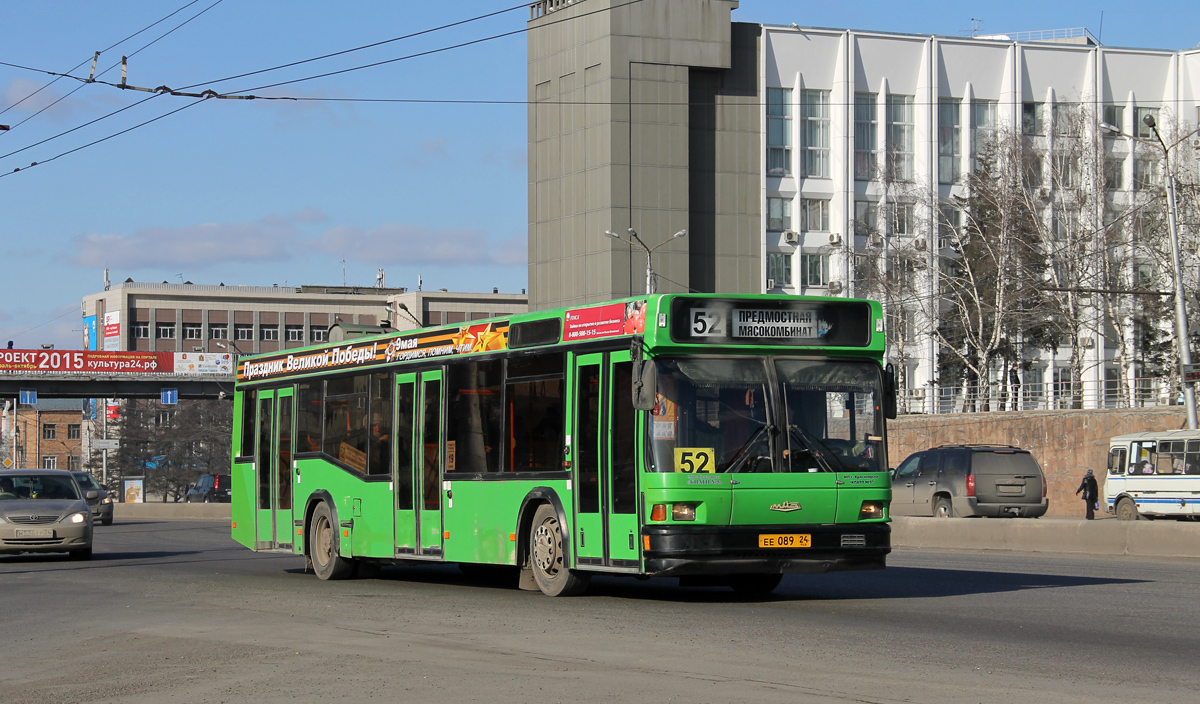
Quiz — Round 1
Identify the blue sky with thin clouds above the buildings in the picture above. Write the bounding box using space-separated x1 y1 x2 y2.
0 0 1200 348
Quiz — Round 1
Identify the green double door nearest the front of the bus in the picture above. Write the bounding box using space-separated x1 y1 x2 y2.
574 351 640 568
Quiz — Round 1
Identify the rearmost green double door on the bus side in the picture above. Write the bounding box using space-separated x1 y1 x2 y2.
254 389 295 549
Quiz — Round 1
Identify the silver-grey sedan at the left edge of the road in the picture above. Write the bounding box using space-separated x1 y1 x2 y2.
0 469 100 560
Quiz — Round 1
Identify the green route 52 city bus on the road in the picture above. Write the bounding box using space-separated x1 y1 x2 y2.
232 294 895 596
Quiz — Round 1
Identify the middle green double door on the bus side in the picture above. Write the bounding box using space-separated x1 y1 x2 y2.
394 371 444 559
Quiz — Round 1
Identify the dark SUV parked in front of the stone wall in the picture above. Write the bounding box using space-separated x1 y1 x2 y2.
892 445 1049 518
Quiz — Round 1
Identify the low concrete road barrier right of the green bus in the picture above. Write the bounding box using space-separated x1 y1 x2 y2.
892 517 1200 558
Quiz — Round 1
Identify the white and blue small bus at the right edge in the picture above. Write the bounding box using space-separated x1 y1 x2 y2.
1104 431 1200 521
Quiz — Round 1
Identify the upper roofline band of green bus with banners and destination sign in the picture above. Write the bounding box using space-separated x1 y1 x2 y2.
238 294 886 385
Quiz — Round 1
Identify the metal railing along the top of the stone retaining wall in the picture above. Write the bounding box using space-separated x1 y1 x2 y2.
896 377 1183 415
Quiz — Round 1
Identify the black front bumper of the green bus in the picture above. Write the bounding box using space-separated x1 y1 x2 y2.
642 523 892 577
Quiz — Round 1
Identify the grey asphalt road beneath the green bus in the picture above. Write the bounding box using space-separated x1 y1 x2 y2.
0 521 1200 704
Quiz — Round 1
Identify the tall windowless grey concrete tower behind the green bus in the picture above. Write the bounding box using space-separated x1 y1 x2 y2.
528 0 762 309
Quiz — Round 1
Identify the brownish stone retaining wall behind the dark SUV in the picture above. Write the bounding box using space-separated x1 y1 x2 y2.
888 407 1186 518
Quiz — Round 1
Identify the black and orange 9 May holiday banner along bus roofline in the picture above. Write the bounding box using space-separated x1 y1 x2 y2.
238 320 509 381
